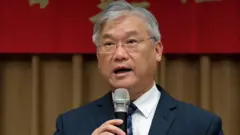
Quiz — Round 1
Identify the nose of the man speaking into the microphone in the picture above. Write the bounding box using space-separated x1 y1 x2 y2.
113 45 128 61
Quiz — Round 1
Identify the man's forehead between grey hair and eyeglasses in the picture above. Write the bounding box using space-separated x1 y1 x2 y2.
100 15 149 39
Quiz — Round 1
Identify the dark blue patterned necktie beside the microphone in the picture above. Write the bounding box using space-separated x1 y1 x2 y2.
127 103 137 135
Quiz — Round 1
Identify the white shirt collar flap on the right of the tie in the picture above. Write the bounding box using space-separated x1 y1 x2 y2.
133 83 161 118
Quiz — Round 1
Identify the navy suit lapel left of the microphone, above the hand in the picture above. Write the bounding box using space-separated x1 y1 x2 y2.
94 92 114 127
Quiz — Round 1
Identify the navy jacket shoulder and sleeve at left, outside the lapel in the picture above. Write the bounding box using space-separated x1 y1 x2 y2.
53 95 109 134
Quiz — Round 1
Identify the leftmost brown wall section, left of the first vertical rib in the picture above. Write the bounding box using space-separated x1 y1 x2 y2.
0 61 32 135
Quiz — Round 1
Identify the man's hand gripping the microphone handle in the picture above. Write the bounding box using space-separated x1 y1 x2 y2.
92 119 126 135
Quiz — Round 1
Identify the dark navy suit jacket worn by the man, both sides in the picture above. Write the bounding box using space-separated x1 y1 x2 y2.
54 85 223 135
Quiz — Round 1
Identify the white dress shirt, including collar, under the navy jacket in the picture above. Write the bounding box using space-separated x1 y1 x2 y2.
132 83 161 135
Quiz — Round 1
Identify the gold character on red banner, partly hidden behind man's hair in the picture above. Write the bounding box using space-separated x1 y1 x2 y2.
90 0 150 22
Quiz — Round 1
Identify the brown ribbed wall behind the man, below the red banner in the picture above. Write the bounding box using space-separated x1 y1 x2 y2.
0 54 240 135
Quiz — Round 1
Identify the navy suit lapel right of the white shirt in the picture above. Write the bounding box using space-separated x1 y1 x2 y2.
149 85 177 135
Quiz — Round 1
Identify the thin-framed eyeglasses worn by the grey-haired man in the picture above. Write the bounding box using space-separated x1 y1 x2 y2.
98 37 154 53
